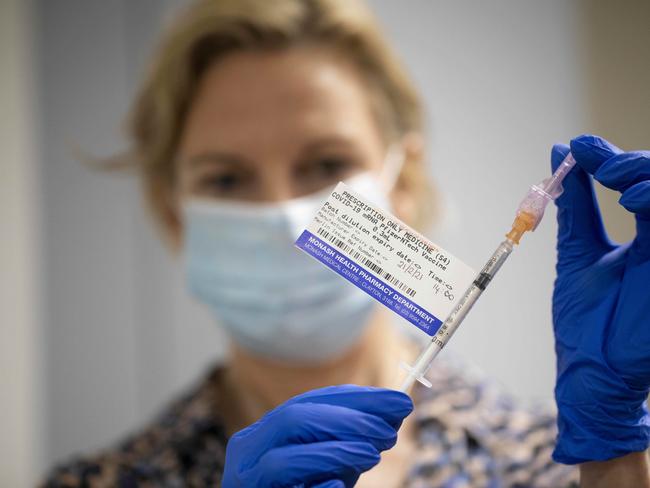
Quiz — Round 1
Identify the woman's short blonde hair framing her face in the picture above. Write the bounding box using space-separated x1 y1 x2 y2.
127 0 430 236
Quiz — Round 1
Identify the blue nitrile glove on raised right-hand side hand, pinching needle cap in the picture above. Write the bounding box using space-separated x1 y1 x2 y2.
552 135 650 464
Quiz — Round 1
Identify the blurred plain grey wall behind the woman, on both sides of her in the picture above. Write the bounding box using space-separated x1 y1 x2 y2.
5 0 640 482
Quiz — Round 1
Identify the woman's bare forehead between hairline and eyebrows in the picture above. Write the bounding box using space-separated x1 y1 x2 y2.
175 48 379 152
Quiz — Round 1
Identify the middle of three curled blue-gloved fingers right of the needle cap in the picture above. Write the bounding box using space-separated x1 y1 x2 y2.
594 151 650 192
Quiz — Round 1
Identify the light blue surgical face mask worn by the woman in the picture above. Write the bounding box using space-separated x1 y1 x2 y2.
184 152 402 362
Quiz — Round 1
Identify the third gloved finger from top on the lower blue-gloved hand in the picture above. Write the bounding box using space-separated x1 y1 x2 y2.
241 441 380 487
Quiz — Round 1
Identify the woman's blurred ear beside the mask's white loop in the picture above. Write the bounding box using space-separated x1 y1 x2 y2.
390 132 425 225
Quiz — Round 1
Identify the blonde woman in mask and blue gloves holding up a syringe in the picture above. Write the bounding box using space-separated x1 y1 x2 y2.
47 0 650 487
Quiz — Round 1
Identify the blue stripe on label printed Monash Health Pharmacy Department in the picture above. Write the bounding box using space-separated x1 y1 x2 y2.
296 230 442 336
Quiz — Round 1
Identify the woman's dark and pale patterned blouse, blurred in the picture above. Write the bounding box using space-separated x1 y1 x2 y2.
43 360 578 488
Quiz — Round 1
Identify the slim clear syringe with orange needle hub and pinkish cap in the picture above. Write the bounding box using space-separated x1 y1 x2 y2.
400 153 576 392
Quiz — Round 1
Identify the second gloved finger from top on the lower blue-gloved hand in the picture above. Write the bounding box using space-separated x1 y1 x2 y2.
240 403 397 451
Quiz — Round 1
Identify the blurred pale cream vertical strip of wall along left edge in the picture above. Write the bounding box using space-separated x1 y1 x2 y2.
0 0 43 487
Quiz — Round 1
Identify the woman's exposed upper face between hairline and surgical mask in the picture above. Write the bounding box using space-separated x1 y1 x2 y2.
177 48 386 206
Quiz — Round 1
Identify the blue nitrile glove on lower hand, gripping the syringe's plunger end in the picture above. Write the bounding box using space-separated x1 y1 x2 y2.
222 385 413 488
